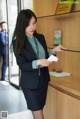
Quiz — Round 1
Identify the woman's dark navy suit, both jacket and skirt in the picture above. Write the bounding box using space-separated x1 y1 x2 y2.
13 34 50 110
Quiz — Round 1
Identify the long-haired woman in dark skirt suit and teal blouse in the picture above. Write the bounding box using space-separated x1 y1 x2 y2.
13 9 63 119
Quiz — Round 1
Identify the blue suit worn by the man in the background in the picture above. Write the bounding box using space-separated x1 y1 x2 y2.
0 31 8 80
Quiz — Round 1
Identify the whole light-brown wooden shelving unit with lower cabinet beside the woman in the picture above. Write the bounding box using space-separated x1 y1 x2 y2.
33 0 80 119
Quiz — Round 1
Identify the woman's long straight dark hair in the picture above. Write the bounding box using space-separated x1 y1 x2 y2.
12 9 37 54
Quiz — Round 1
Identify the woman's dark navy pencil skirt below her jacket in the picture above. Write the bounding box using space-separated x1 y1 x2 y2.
22 82 48 111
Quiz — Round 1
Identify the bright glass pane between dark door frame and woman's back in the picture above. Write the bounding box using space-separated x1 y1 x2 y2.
7 0 19 86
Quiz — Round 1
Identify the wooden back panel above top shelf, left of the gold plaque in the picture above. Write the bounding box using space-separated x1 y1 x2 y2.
33 0 58 17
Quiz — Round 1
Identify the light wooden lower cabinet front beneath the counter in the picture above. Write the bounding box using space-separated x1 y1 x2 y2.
44 86 80 119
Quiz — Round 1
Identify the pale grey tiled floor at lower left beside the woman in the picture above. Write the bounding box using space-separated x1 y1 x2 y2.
0 81 33 119
